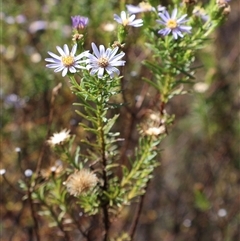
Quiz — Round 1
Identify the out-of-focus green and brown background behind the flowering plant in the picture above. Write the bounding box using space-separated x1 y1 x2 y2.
0 0 240 241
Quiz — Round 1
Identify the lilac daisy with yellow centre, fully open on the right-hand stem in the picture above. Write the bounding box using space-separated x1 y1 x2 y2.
156 8 192 39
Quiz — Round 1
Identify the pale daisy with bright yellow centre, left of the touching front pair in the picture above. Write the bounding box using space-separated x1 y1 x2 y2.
45 44 88 77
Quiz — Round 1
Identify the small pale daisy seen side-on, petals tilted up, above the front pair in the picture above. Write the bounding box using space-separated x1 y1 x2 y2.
114 11 143 27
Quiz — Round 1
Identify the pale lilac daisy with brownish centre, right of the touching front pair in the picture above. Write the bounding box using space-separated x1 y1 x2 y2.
86 43 126 79
